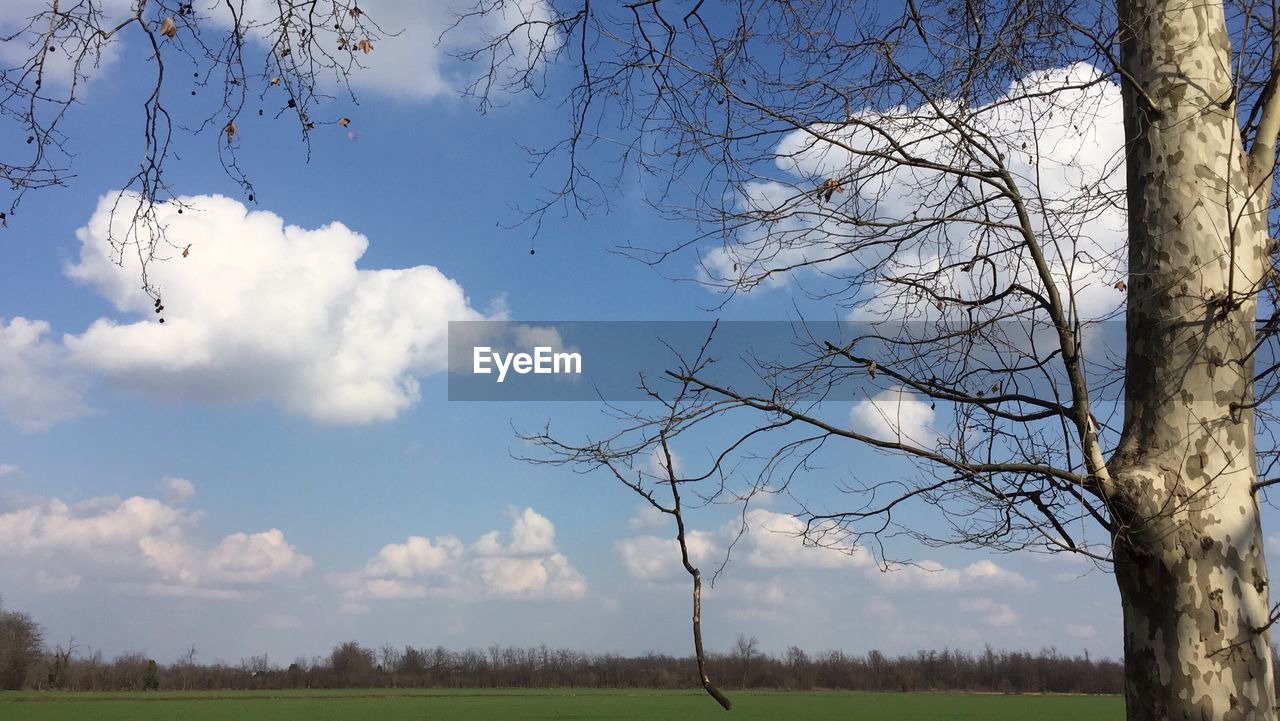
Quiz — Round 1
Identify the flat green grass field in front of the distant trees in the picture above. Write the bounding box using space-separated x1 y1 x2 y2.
0 689 1124 721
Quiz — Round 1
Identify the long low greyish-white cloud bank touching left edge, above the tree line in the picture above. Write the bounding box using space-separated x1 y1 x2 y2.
0 496 311 598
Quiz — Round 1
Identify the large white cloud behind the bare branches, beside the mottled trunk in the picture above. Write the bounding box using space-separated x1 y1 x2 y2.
700 63 1125 318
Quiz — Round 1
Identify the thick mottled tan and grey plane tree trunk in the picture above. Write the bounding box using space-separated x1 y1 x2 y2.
1105 0 1275 721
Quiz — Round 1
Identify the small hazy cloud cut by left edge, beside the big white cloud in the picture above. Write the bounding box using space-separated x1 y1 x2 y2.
0 318 88 432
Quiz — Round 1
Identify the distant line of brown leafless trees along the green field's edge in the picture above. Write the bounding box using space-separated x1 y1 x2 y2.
0 608 1123 694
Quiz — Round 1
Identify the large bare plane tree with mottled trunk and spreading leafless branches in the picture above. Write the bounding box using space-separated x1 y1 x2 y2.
463 0 1280 721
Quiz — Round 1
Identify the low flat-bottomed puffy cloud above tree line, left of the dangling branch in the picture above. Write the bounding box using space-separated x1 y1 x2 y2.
329 508 586 612
